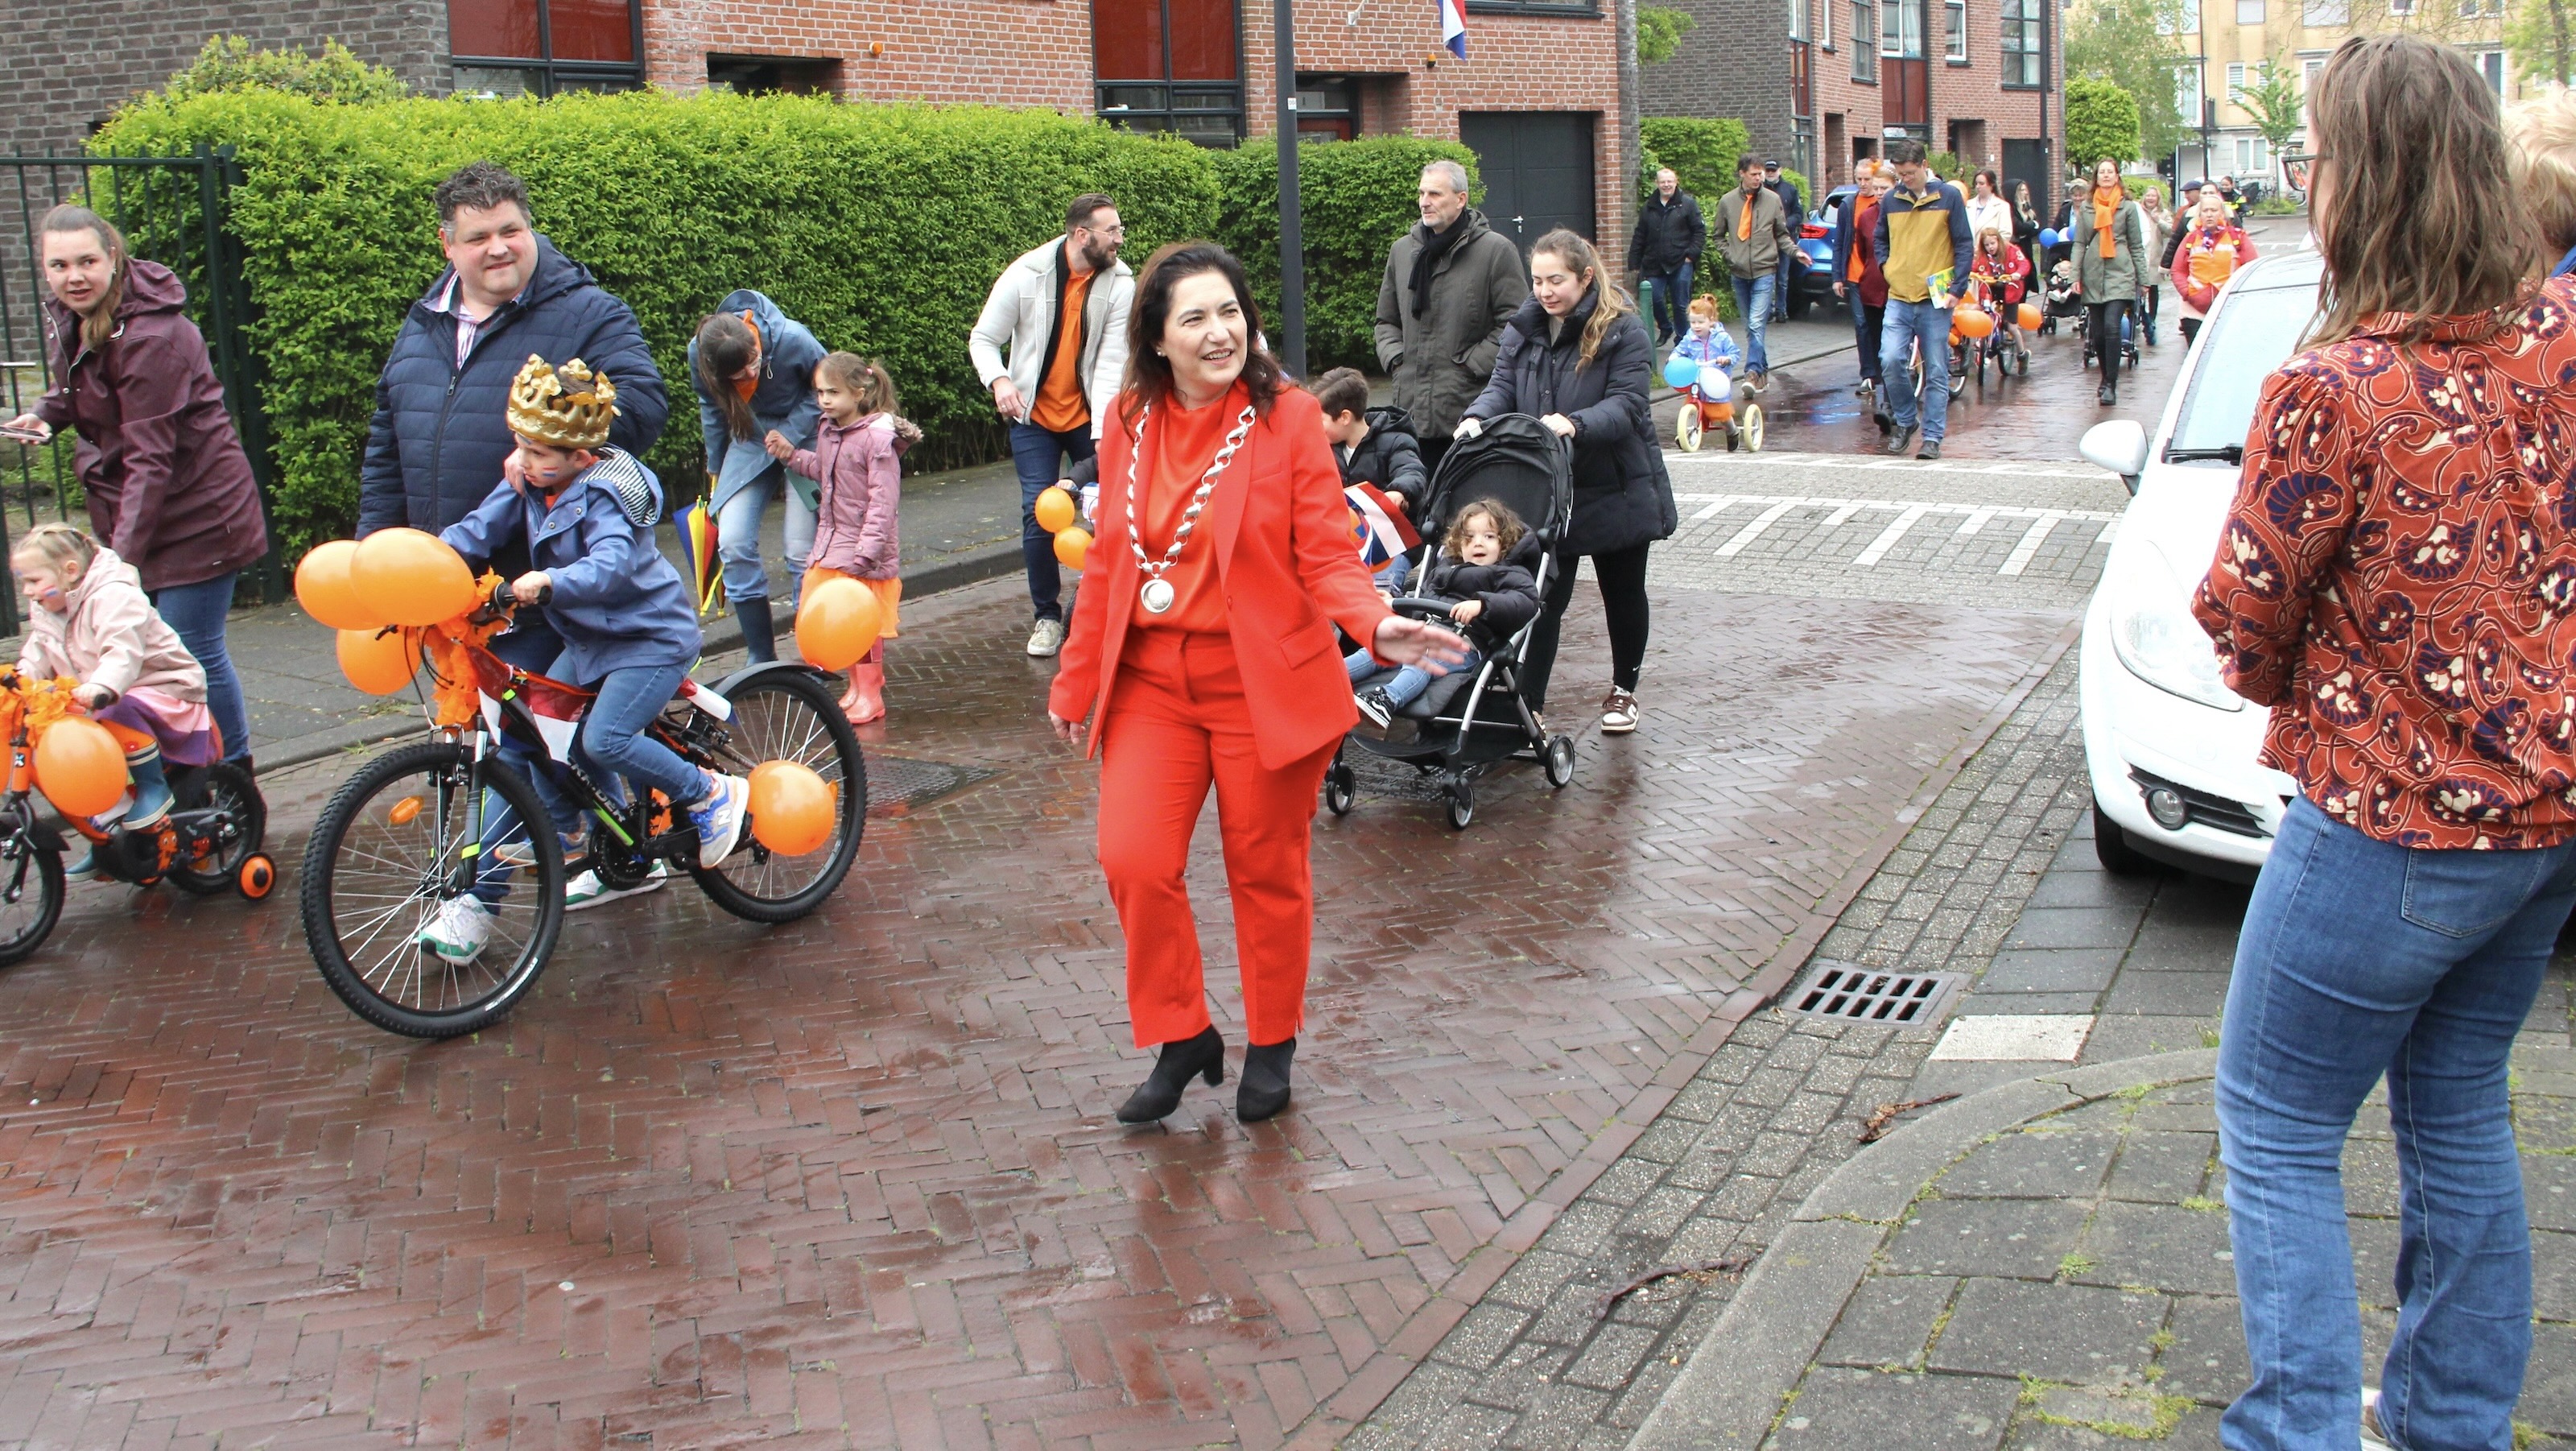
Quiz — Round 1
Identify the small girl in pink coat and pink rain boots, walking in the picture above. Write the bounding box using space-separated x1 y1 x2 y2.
762 353 923 724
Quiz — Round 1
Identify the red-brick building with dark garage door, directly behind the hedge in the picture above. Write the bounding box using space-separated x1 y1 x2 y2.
448 0 1636 253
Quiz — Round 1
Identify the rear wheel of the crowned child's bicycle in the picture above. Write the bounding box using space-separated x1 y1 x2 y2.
687 670 868 923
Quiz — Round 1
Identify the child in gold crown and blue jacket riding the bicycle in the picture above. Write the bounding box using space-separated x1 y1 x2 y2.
420 356 752 961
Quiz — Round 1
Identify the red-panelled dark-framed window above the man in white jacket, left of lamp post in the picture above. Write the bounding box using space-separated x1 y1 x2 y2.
1092 0 1245 147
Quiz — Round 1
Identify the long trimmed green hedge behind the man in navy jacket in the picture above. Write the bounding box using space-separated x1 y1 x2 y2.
93 90 1219 556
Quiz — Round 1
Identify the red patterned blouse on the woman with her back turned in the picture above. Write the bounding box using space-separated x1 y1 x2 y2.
2192 279 2576 848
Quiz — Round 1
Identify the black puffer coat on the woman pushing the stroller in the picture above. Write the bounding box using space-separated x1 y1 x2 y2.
1466 286 1677 560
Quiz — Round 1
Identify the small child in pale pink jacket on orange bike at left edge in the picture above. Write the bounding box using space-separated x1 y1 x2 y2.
8 523 224 882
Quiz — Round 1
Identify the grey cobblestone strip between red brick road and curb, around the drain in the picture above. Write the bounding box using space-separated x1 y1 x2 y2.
1344 650 2087 1451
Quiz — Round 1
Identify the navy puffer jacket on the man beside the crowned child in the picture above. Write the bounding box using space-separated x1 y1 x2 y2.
358 237 670 536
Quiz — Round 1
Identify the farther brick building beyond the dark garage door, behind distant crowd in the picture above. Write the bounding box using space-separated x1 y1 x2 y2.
1644 0 2066 215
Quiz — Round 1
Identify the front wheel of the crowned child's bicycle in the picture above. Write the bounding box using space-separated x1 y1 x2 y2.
304 740 564 1039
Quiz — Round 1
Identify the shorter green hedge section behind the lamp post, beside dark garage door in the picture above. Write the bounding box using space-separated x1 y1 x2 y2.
1211 137 1479 374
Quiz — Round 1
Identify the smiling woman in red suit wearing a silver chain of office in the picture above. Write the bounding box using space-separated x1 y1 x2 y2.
1046 242 1466 1124
